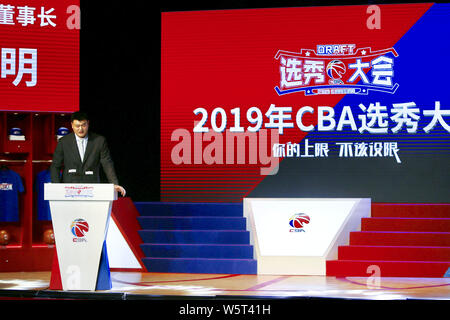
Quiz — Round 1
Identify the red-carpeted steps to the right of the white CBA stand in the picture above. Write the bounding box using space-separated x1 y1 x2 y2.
327 203 450 278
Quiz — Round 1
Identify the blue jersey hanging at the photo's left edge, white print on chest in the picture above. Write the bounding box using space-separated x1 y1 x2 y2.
0 169 24 222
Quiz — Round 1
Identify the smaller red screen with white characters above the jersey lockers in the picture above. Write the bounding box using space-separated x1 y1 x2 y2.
0 0 80 112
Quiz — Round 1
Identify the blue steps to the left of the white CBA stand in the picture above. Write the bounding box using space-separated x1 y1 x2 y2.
135 202 256 274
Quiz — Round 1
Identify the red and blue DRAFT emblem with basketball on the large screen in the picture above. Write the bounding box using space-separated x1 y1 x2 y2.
275 44 399 96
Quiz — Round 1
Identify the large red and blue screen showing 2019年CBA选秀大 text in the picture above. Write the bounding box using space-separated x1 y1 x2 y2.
161 3 450 202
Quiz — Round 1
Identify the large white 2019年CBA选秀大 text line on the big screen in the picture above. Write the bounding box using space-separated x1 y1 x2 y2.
194 101 450 135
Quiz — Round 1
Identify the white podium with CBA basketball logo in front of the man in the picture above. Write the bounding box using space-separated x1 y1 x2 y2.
44 183 117 291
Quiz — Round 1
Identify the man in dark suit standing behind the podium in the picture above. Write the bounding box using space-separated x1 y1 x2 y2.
50 112 126 196
